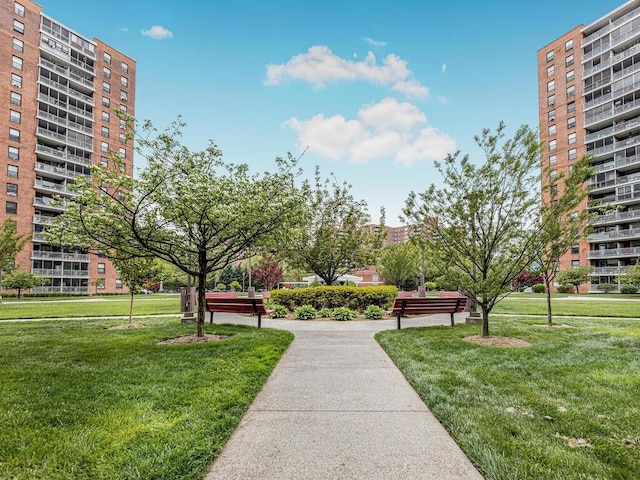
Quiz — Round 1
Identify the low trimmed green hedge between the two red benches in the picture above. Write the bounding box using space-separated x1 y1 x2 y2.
271 286 398 312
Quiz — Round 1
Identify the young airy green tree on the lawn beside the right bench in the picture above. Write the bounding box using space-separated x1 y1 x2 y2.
403 123 540 336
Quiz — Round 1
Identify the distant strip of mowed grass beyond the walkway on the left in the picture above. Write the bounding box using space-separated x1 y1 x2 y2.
0 295 180 320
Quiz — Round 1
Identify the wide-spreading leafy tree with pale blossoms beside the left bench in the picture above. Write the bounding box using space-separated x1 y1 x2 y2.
47 114 305 337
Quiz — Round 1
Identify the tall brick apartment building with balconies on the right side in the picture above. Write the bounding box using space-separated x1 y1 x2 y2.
538 0 640 291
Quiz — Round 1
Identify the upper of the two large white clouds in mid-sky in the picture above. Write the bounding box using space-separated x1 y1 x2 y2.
264 45 429 97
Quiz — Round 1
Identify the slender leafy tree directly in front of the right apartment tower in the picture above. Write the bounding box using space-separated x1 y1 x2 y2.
535 155 593 326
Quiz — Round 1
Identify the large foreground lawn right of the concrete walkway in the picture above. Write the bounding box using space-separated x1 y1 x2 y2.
377 318 640 480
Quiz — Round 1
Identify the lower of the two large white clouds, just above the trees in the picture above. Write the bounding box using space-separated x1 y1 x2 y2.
284 98 456 165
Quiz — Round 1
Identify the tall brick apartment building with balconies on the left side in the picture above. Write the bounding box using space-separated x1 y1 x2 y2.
0 0 136 294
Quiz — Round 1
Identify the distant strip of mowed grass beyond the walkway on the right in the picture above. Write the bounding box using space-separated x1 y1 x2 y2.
492 296 640 318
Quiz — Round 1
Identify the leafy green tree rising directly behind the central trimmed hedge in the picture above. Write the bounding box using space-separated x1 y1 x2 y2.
284 168 386 285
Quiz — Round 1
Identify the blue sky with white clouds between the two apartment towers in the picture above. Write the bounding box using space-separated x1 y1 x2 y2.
39 0 623 225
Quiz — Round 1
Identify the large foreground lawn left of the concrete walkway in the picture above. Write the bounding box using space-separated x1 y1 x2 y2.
0 318 293 480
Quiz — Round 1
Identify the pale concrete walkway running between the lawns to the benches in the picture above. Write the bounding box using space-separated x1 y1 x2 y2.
205 314 482 480
